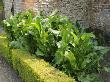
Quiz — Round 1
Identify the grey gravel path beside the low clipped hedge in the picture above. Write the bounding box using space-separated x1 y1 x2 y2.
0 56 22 82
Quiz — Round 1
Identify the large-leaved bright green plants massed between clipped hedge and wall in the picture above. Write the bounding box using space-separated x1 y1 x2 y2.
4 11 108 81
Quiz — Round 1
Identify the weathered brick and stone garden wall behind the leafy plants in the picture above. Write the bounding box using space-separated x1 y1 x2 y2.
4 0 110 32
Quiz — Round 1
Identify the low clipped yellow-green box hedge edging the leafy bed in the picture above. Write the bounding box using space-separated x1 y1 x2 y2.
0 35 76 82
